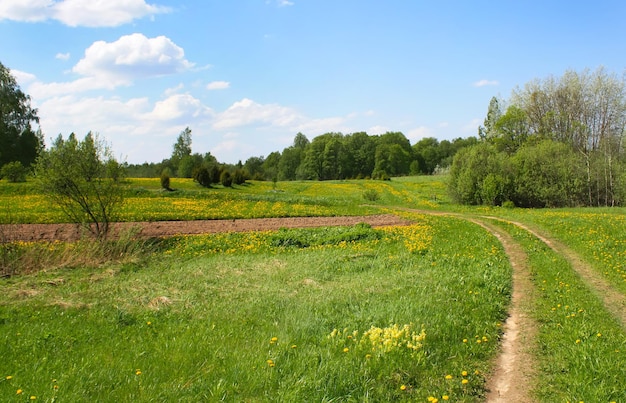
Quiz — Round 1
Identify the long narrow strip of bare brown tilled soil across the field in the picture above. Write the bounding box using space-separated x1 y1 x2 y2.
0 214 411 242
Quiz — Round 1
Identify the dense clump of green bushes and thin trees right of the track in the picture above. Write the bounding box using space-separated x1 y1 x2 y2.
449 68 626 207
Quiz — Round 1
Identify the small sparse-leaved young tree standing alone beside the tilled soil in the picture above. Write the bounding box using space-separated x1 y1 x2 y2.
35 132 124 239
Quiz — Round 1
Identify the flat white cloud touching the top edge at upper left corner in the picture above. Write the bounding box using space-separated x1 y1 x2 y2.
0 0 171 27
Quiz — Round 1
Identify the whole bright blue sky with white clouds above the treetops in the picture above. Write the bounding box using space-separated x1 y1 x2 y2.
0 0 626 163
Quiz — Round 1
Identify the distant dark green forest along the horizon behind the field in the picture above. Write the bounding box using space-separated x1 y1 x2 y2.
127 128 478 184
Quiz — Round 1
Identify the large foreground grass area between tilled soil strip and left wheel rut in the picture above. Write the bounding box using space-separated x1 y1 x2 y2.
0 215 511 402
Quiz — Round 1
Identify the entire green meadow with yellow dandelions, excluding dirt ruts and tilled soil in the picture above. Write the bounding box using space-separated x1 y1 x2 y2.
0 177 626 402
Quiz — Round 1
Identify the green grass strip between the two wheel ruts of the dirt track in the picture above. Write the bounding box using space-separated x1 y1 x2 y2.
488 222 626 402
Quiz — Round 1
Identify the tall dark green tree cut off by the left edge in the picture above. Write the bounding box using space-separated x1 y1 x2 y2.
0 63 44 167
